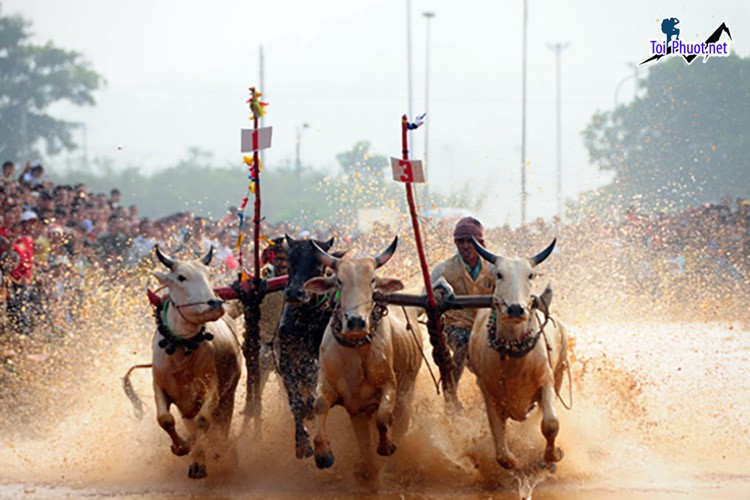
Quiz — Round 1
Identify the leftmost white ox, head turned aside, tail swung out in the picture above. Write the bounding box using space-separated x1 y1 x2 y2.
125 247 242 479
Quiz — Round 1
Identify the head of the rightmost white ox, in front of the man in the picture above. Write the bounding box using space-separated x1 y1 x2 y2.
472 238 557 323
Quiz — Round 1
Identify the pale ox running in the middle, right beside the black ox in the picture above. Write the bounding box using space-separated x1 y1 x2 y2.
305 238 422 482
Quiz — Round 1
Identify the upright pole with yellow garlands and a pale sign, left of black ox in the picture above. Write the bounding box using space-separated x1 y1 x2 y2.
234 87 272 431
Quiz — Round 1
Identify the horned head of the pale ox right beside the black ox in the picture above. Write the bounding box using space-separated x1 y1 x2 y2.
305 236 404 336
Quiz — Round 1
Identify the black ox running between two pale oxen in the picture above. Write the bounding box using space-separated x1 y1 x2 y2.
279 235 343 458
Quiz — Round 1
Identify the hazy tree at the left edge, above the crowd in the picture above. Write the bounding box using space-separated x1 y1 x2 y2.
0 7 104 161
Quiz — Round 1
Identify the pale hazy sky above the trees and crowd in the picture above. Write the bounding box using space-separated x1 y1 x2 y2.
2 0 750 224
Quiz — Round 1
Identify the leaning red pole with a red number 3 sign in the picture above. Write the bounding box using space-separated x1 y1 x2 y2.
391 114 460 410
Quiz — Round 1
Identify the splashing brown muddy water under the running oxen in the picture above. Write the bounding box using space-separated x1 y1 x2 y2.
0 315 750 499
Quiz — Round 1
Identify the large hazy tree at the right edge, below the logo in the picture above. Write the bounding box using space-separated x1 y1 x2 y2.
583 56 750 208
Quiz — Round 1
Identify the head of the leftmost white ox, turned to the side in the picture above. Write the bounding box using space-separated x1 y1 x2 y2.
151 245 224 324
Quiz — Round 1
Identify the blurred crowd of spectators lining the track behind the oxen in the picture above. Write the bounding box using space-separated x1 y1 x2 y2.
0 154 750 335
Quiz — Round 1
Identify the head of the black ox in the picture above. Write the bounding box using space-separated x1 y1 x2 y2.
284 234 340 304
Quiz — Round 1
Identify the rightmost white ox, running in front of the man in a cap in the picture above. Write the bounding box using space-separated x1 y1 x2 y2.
469 240 568 469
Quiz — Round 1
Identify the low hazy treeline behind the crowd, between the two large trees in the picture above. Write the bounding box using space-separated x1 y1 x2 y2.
51 141 482 228
